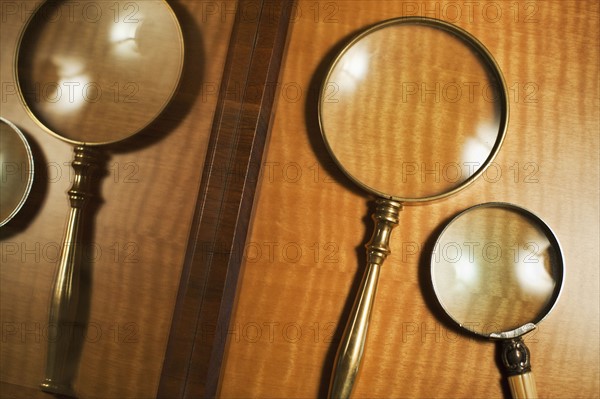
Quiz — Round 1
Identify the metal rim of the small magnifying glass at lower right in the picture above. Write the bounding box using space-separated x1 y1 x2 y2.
429 202 565 339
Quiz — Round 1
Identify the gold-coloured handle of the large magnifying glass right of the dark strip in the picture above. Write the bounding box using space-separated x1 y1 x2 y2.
329 199 402 399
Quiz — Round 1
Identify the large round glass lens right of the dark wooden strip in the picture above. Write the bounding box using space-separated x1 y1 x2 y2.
320 22 503 201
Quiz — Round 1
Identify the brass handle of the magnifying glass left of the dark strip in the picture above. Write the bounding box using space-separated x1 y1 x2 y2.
40 146 97 395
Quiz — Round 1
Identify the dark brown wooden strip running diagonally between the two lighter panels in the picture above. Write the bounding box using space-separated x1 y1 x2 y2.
157 0 294 398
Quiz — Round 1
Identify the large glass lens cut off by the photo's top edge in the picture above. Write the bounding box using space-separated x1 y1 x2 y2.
17 0 183 144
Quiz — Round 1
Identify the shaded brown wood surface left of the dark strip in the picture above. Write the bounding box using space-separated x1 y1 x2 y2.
0 0 236 398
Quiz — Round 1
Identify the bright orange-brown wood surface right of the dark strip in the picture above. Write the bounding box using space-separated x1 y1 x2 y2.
219 1 600 398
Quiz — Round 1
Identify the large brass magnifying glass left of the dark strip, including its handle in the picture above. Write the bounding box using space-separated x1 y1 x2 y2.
16 0 184 394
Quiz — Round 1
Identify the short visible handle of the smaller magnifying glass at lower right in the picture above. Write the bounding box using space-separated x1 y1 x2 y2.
502 337 538 399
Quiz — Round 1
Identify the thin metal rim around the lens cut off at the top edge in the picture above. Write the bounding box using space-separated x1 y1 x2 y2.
13 0 185 146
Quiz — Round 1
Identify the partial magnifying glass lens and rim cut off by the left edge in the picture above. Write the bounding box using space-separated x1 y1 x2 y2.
0 117 34 227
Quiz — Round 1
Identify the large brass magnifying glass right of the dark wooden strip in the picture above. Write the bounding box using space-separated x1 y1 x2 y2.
319 17 508 398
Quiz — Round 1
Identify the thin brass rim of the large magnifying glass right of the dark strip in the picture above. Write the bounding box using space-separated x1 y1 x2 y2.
318 17 509 204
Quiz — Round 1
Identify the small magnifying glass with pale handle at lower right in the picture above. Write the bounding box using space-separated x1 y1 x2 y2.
431 202 564 398
